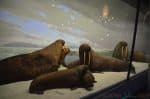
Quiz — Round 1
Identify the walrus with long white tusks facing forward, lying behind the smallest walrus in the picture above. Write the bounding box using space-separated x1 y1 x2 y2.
66 44 135 73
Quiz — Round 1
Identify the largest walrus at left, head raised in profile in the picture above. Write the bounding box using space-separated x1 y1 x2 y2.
0 39 70 85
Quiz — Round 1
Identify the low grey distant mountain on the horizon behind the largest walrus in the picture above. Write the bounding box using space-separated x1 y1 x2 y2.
2 42 44 48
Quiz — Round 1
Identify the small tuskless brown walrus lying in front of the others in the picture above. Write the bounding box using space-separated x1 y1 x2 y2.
29 65 96 94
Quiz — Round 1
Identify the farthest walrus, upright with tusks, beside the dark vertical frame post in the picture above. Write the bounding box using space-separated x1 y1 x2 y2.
112 41 129 61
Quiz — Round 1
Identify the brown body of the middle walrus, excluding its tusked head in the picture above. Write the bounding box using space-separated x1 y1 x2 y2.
89 55 128 72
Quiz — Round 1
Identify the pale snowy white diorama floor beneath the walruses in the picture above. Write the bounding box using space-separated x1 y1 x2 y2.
0 62 148 99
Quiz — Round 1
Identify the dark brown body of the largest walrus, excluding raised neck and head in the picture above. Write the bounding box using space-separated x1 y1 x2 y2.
0 51 59 84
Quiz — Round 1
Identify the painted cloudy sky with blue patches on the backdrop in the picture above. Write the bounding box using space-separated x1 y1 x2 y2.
0 0 149 52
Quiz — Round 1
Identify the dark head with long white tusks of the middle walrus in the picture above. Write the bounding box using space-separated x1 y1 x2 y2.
79 44 92 65
